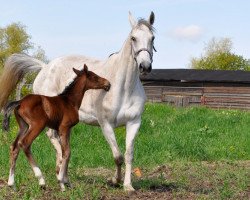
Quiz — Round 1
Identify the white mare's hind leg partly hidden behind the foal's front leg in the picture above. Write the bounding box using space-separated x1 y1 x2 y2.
46 129 62 178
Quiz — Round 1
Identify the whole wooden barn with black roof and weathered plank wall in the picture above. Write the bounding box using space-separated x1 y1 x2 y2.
140 69 250 110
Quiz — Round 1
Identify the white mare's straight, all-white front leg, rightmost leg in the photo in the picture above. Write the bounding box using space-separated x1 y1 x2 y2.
123 118 141 192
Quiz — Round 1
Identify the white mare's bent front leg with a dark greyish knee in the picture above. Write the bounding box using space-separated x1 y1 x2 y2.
101 123 124 186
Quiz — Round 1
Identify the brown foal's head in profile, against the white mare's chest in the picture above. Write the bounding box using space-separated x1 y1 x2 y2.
73 64 111 91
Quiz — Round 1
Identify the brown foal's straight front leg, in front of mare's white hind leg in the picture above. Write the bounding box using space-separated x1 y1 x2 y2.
58 127 70 191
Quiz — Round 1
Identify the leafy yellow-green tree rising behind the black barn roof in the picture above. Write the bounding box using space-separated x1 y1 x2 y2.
190 38 250 71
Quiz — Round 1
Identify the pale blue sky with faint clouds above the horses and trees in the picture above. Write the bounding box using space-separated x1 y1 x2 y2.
0 0 250 69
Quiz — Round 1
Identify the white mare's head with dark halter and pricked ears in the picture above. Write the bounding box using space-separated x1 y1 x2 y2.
129 12 155 74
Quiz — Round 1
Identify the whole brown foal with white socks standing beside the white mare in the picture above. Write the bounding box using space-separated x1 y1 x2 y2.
3 65 110 191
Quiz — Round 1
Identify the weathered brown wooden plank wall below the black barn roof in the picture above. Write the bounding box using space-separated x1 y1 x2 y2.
144 86 250 110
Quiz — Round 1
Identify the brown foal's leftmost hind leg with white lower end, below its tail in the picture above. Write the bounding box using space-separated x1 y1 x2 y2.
8 110 28 187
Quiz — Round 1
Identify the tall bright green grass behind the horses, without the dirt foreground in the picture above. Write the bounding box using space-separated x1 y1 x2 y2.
0 104 250 198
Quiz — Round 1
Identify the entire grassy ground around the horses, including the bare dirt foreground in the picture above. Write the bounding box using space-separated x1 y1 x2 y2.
0 104 250 199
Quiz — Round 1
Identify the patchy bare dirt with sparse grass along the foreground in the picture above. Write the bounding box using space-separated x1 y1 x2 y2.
0 161 250 200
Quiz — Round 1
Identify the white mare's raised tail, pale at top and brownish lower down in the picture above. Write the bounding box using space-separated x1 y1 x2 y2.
0 54 45 111
